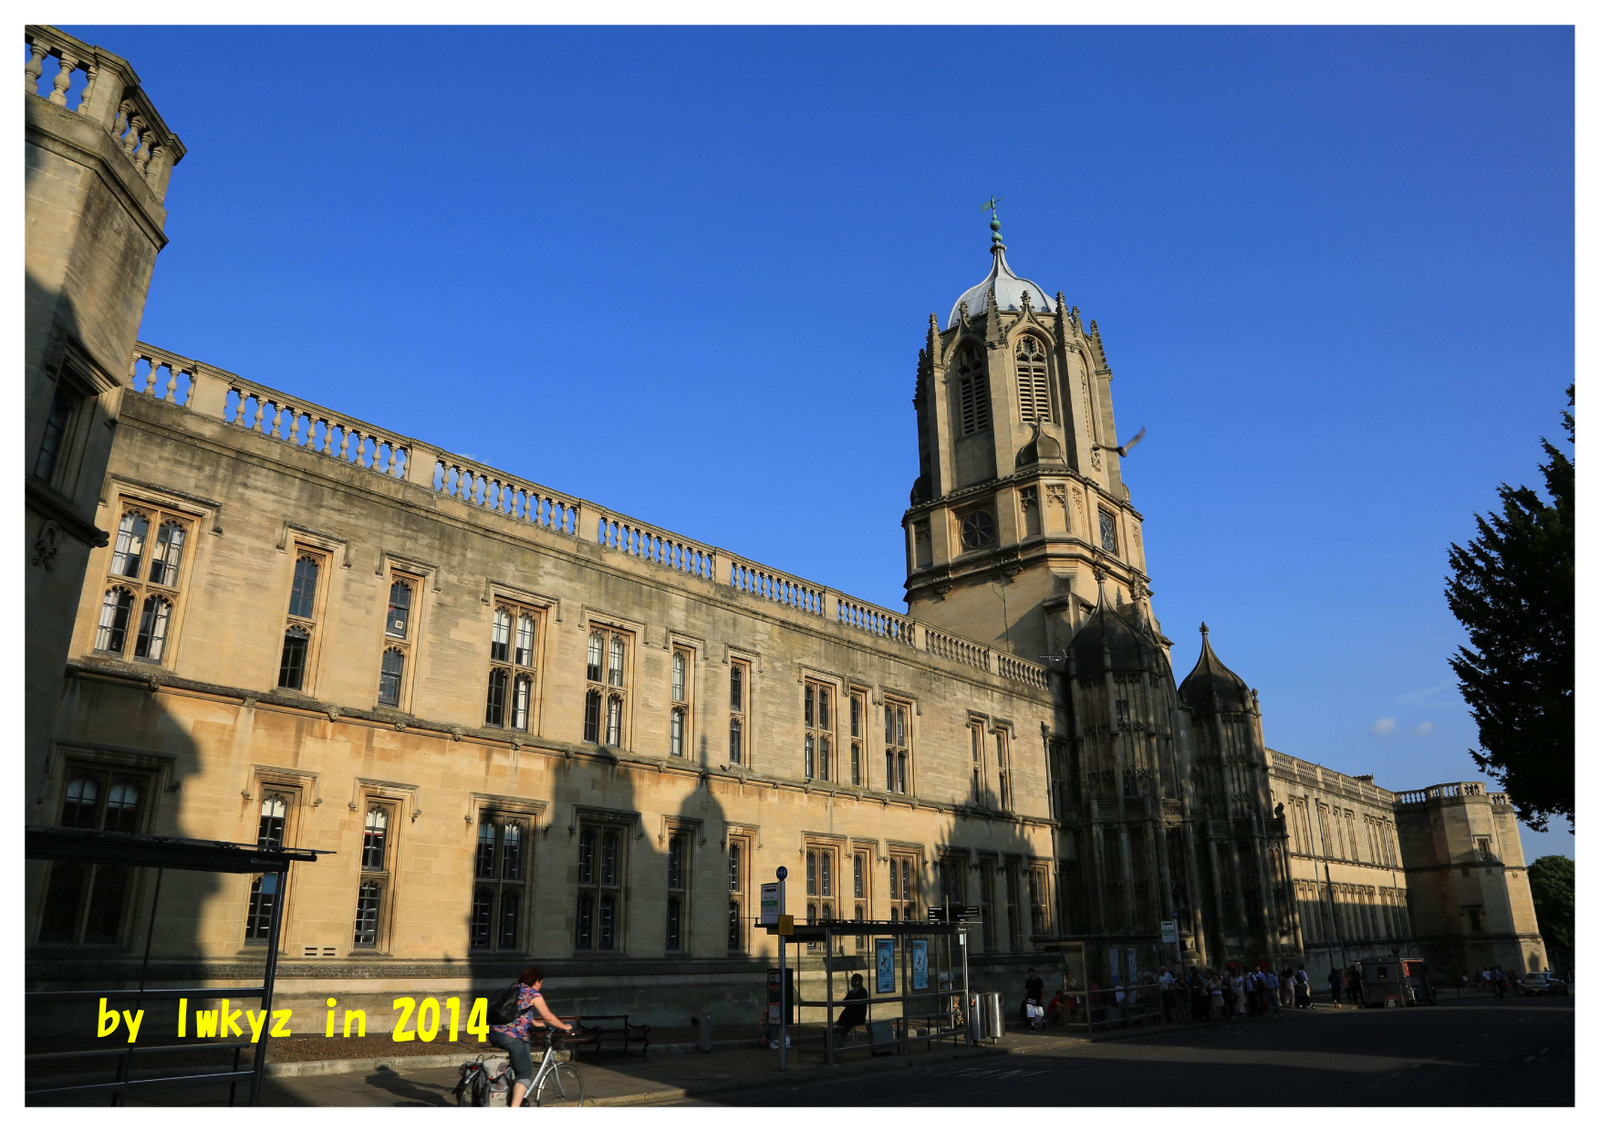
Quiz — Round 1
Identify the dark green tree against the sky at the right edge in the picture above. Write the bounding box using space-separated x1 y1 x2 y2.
1445 387 1574 830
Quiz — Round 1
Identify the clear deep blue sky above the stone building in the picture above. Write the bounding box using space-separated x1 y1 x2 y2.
67 26 1574 859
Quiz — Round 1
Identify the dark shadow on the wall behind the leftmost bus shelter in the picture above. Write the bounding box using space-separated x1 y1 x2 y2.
24 681 252 1105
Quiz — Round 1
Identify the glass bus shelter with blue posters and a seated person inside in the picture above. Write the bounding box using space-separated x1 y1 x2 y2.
778 919 970 1065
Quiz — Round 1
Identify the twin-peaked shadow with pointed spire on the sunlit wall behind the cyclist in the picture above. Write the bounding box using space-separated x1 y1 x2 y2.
464 729 736 1028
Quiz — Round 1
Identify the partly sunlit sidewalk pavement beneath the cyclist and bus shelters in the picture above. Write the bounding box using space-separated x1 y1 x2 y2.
261 1026 1100 1108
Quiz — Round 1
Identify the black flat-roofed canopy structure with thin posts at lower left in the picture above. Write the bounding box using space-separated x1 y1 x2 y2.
24 825 325 1105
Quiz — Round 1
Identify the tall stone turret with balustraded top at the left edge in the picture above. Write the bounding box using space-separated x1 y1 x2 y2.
22 26 184 772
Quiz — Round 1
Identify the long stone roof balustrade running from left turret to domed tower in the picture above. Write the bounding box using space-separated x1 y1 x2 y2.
126 334 1050 689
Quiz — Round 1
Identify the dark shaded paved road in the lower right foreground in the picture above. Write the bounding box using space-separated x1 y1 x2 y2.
683 998 1574 1106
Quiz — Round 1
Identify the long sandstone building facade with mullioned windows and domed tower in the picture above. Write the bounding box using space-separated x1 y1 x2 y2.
26 28 1548 1020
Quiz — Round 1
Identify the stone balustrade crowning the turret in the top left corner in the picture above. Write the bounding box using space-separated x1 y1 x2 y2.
22 24 184 201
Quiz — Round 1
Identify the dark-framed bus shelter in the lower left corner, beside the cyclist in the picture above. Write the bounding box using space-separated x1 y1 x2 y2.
24 825 325 1105
